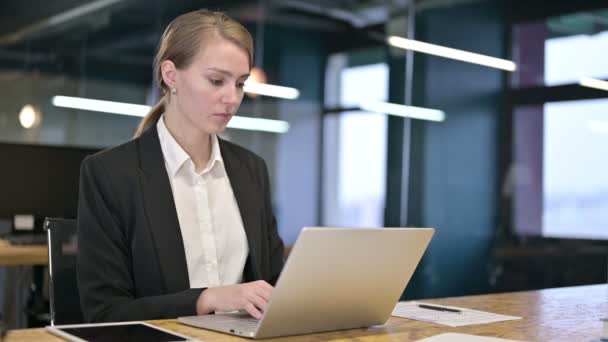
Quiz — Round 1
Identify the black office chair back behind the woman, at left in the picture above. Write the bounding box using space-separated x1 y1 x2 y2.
44 218 84 325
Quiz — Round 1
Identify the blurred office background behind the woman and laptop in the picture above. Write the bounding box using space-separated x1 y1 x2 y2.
0 0 608 327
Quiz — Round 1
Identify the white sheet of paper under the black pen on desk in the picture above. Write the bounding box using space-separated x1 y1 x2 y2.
392 302 521 327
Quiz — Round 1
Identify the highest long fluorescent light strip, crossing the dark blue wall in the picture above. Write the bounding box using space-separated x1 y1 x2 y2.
387 36 517 71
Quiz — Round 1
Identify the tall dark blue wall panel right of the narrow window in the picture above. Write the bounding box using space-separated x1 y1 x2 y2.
405 2 506 298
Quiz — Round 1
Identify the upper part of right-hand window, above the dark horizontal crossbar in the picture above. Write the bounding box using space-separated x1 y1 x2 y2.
511 9 608 88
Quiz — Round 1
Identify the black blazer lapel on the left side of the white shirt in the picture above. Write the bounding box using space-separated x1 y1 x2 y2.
139 125 190 293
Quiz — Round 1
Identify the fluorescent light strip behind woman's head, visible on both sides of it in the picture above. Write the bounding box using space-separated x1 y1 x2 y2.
51 96 289 133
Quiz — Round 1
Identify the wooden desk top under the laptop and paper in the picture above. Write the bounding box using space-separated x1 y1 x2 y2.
6 285 608 341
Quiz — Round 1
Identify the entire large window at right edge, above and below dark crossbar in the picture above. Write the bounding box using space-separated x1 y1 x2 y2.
505 9 608 240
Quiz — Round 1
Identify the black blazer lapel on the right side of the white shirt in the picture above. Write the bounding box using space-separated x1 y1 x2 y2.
218 138 262 280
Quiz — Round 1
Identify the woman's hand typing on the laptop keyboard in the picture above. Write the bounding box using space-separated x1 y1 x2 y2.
196 280 273 319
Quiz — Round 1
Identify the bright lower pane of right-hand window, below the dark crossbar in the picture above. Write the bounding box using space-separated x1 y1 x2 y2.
543 99 608 239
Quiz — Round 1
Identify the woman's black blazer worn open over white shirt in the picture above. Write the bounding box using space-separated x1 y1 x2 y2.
76 125 283 322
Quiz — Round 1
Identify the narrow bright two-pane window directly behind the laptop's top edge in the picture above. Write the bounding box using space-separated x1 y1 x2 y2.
322 59 388 227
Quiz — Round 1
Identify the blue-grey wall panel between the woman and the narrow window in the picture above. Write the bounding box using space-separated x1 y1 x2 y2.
264 27 327 245
